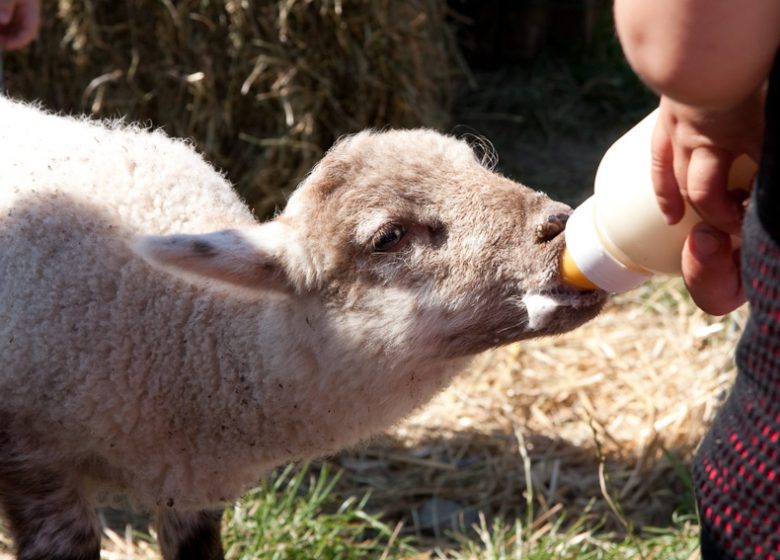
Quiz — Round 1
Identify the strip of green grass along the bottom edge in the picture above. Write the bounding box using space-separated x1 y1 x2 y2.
223 462 698 560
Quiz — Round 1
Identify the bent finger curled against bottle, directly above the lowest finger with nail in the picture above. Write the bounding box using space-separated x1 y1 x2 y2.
683 147 743 233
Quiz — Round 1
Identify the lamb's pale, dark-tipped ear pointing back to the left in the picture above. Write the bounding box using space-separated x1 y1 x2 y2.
135 221 296 291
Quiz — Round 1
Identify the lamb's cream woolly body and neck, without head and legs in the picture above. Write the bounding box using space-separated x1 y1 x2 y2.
0 99 468 509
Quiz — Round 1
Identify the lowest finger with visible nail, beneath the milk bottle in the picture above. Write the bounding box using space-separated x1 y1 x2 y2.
682 223 745 315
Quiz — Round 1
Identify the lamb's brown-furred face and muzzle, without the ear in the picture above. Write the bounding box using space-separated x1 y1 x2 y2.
282 130 604 355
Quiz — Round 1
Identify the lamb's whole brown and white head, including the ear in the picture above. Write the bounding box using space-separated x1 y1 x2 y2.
142 130 604 357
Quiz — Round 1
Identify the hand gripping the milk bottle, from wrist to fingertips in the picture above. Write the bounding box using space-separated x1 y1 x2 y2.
652 95 763 315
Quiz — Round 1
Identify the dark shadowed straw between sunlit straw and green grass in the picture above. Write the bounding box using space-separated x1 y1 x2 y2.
332 424 693 545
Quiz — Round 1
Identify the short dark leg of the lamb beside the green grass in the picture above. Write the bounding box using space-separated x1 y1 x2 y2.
157 509 225 560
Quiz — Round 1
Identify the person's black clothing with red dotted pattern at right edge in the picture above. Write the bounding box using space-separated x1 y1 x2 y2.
694 53 780 560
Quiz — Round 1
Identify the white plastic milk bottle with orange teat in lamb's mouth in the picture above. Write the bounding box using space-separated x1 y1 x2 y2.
561 110 756 293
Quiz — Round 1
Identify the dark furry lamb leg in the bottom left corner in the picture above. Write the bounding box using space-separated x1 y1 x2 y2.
0 464 100 560
